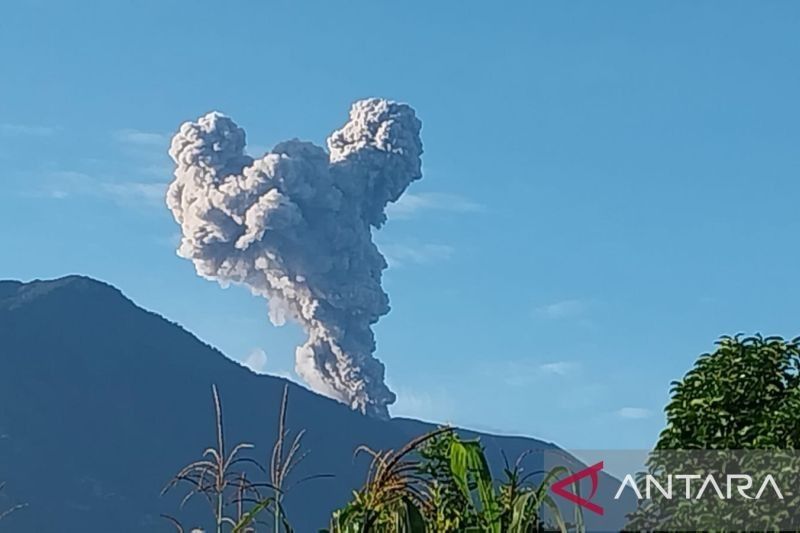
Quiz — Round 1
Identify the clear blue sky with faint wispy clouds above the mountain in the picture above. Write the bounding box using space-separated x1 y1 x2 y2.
0 0 800 449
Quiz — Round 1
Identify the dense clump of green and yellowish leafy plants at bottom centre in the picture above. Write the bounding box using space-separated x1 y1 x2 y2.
330 428 583 533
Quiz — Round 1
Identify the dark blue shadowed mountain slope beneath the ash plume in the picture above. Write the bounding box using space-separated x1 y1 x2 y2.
0 276 632 533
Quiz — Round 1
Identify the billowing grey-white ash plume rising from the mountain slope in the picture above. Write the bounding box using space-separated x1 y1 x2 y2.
167 99 422 417
